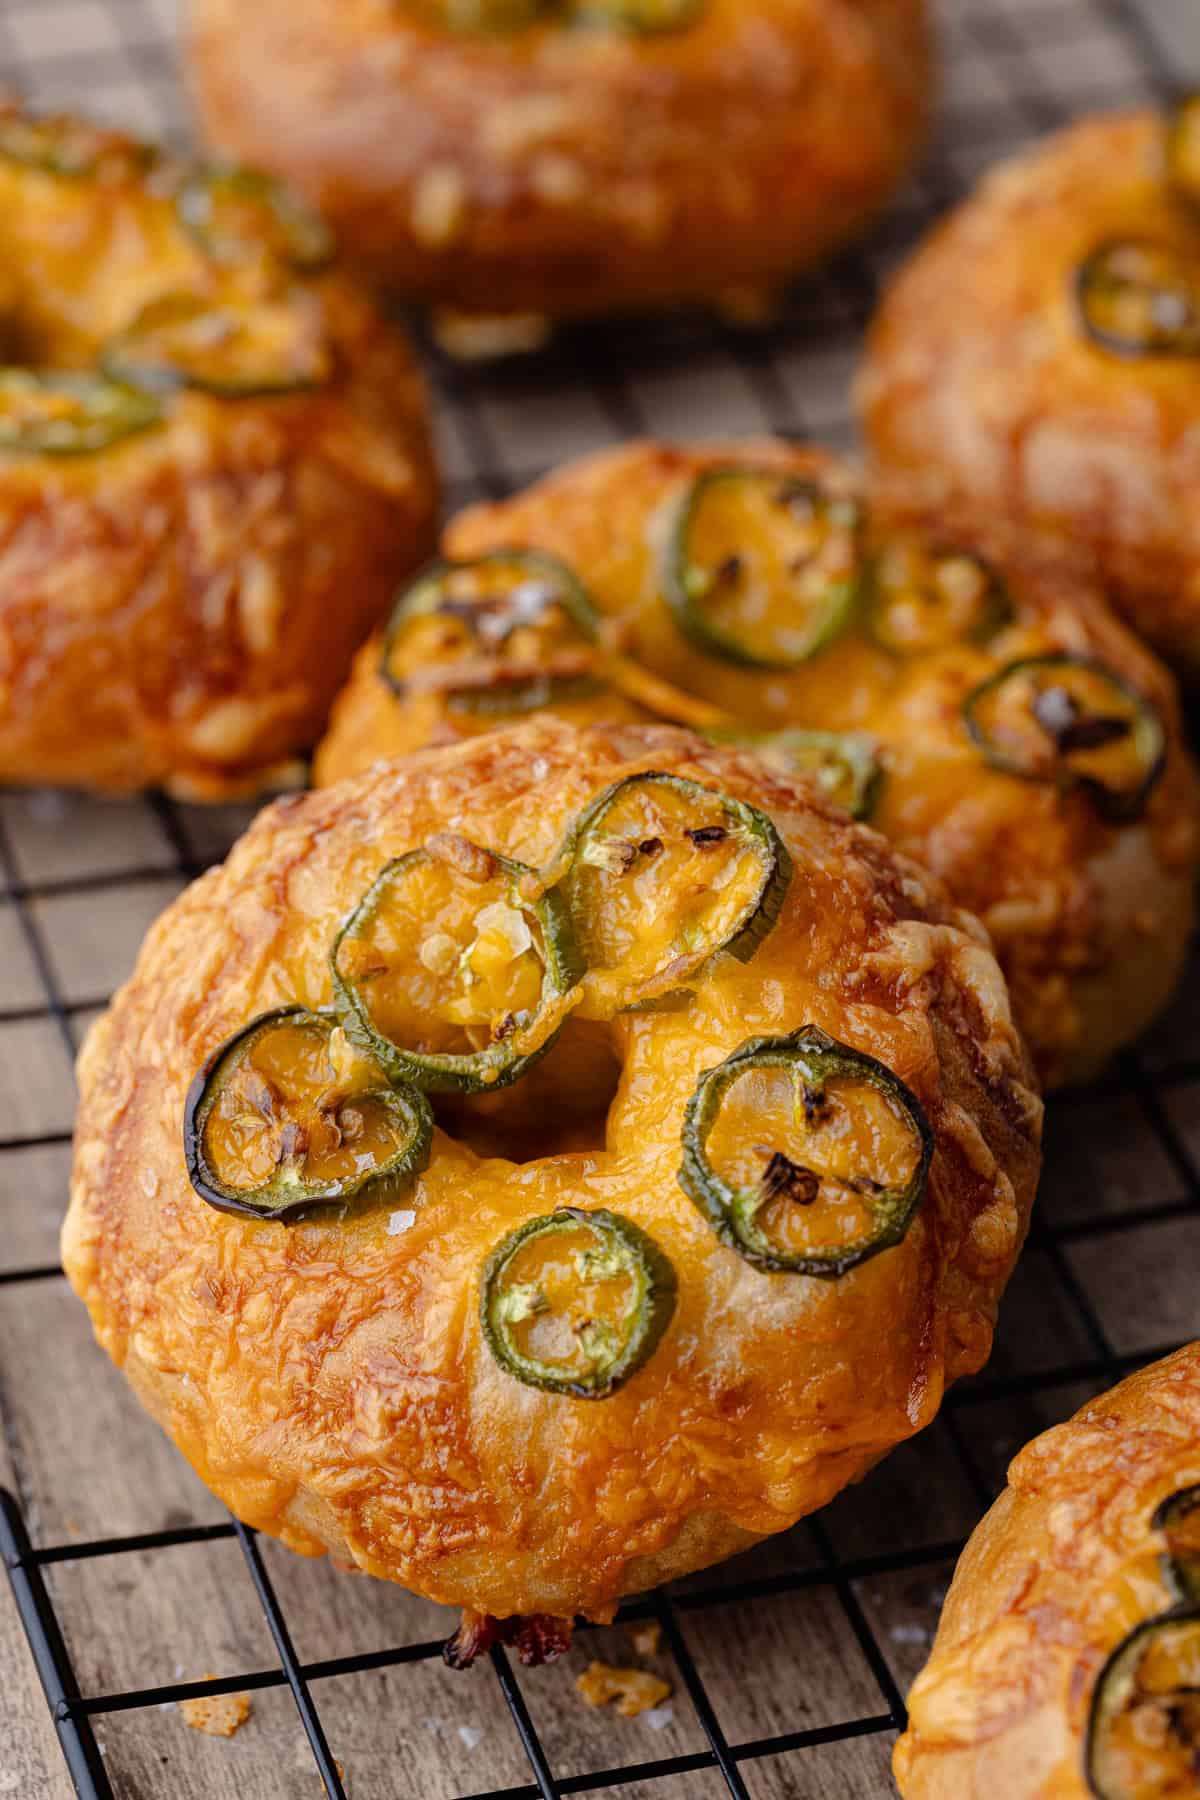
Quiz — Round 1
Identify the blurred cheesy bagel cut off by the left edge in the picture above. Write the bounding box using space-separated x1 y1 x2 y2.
0 106 437 799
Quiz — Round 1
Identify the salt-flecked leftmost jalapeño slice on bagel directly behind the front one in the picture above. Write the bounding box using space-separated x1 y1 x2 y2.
380 549 599 715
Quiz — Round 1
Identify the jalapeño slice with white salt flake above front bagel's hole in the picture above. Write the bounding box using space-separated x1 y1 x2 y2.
331 832 579 1093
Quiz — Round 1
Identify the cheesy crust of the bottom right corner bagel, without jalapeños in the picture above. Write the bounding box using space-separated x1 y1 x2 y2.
894 1345 1200 1800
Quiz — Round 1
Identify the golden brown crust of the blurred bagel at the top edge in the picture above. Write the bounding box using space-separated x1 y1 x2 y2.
191 0 932 315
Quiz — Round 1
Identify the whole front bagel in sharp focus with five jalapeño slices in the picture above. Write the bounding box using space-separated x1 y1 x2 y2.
63 718 1040 1660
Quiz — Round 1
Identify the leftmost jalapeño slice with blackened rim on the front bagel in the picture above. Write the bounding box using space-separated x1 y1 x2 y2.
184 1006 434 1222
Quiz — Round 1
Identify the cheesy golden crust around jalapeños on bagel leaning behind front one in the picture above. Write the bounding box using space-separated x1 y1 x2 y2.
315 441 1198 1082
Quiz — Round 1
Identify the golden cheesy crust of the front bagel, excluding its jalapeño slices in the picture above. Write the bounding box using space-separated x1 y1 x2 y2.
63 718 1040 1616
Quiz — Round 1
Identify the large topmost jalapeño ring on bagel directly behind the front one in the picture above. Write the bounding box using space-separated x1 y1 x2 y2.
664 468 862 670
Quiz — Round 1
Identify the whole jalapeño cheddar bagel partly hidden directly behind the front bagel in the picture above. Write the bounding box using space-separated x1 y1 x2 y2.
317 443 1196 1082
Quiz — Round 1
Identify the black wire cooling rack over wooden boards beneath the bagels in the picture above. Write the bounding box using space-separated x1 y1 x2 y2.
0 0 1200 1800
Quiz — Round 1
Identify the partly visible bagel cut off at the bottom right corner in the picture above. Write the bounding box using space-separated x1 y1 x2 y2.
894 1345 1200 1800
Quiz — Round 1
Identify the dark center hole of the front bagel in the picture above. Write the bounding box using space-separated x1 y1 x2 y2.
432 1019 621 1163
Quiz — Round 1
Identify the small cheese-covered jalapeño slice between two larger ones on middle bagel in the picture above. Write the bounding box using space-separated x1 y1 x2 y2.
865 538 1013 657
